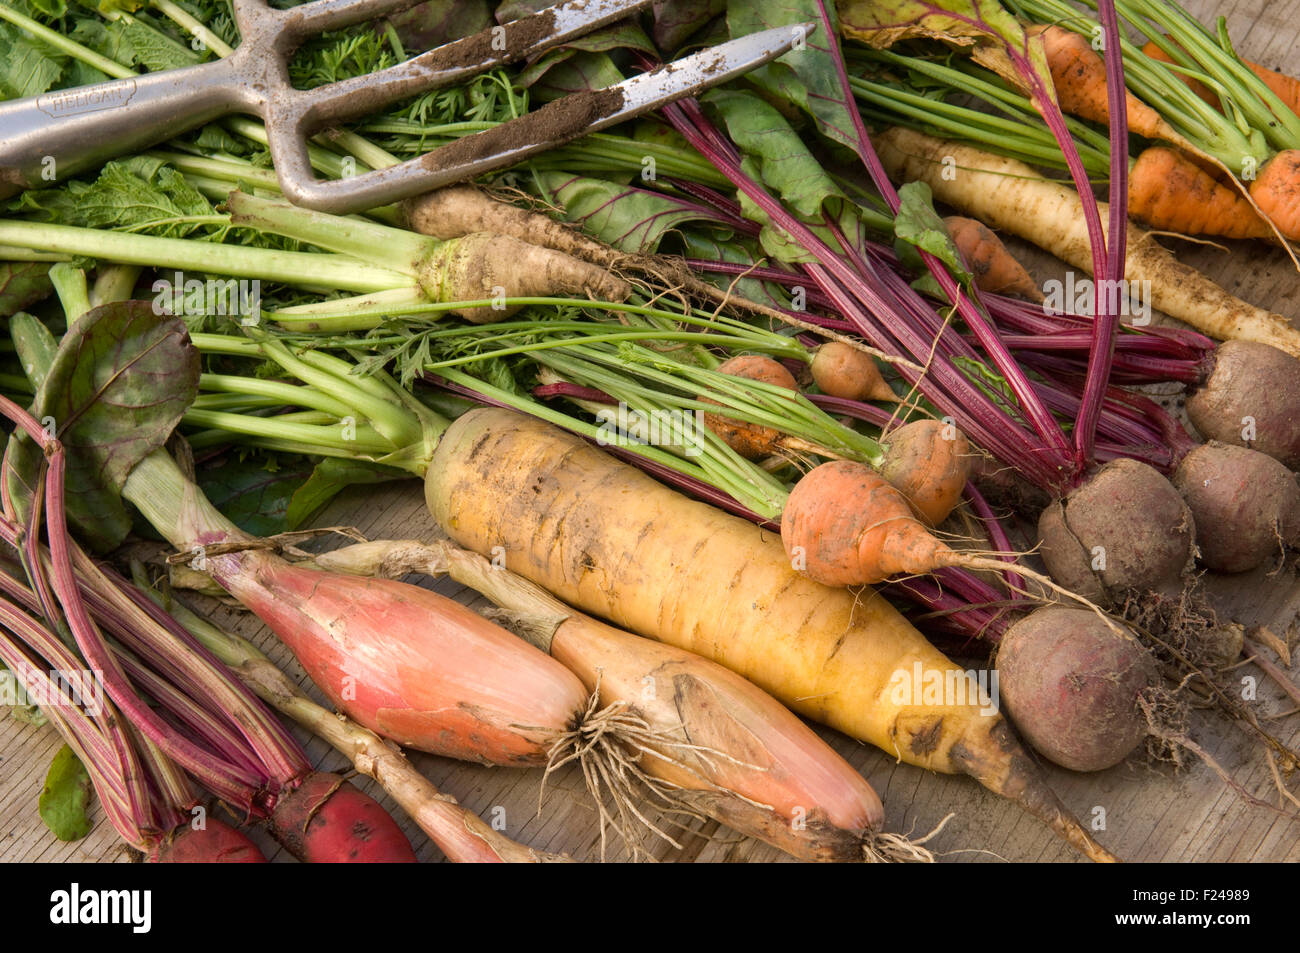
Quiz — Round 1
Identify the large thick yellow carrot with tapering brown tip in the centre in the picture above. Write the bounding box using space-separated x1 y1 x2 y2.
425 408 1114 859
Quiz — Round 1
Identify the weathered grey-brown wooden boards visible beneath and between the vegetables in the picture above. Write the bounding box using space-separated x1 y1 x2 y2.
0 0 1300 862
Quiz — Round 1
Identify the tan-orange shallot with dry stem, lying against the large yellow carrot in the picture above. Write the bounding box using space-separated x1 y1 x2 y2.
319 541 936 861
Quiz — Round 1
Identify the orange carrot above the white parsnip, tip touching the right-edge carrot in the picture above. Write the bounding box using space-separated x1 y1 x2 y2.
1128 146 1273 238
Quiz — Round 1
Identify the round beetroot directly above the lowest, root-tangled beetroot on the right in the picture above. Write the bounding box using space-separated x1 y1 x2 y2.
1039 459 1195 605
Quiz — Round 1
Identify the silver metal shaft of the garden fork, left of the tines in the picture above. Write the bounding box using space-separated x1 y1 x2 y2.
0 60 245 198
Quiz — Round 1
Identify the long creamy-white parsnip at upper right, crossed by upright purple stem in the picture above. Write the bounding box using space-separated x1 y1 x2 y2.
874 127 1300 355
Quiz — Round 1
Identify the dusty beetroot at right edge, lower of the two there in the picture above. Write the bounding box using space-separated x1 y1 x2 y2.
1174 441 1300 572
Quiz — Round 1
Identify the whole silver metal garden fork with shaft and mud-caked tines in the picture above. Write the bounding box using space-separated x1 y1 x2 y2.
0 0 813 213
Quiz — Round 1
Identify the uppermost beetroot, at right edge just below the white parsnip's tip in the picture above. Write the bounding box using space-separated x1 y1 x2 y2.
1187 341 1300 469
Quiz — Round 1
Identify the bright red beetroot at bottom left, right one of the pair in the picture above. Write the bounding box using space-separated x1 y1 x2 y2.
270 771 416 863
